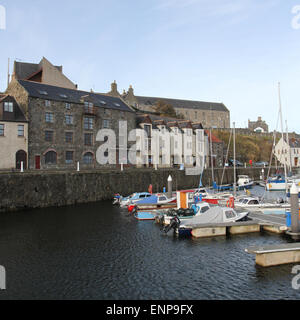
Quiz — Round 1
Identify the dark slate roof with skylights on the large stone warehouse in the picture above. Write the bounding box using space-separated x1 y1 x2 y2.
18 80 133 113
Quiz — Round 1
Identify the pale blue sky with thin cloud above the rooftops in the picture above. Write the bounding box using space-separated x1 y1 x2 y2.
0 0 300 133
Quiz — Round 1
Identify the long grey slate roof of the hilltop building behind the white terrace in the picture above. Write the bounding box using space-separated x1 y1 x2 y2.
136 96 229 112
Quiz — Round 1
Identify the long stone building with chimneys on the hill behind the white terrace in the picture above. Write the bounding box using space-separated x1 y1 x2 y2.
108 81 230 128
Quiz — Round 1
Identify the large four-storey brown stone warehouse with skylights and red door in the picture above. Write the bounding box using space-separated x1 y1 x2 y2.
7 80 136 169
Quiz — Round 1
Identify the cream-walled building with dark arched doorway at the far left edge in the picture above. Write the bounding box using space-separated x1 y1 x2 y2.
0 95 28 170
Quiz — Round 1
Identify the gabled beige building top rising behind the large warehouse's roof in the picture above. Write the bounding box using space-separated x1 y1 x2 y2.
12 57 77 90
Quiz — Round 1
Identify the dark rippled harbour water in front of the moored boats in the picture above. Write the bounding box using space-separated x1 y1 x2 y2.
0 188 300 300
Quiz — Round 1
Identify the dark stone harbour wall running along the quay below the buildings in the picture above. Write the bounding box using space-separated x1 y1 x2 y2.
0 168 276 212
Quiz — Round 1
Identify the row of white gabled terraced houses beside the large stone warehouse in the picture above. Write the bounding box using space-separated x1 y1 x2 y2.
137 114 208 168
